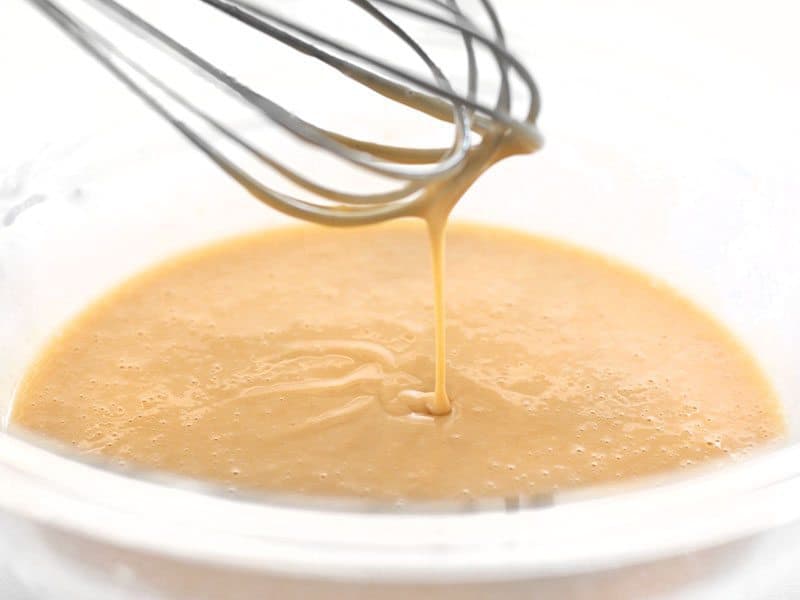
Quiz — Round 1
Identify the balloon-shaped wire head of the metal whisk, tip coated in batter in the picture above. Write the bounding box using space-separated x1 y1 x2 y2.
29 0 540 224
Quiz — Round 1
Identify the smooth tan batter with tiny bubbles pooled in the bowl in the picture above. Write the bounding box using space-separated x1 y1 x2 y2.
12 223 784 499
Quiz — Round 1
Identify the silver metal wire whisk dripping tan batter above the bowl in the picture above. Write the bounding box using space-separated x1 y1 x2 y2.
29 0 540 225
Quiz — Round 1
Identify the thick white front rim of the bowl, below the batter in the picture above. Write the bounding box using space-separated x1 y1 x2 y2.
0 434 800 583
